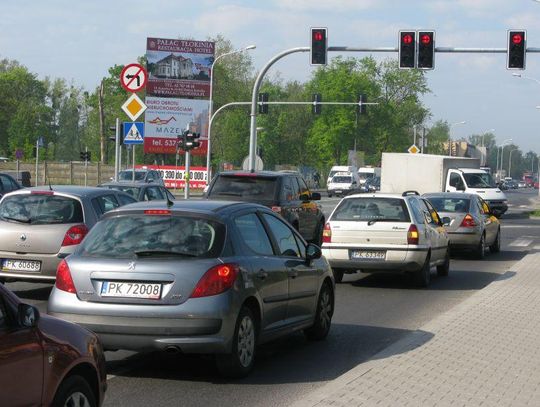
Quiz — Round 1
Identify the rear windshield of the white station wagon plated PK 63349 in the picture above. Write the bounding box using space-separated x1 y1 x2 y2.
330 197 411 222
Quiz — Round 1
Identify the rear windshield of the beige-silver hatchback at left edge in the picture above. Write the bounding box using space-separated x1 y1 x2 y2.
0 192 83 225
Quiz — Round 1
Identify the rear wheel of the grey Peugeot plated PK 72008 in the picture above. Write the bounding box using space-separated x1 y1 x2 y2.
216 306 257 379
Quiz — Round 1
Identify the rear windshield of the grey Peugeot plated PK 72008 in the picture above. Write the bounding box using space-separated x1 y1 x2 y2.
79 214 225 258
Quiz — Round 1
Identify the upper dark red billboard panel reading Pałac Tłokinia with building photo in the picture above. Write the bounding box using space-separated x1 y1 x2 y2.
146 38 214 98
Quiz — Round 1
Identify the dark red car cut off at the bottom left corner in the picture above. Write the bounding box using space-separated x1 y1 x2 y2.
0 284 107 407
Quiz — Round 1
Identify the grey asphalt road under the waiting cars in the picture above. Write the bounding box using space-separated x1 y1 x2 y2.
8 190 540 406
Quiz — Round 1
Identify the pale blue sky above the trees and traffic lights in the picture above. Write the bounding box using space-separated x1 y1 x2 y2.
0 0 540 153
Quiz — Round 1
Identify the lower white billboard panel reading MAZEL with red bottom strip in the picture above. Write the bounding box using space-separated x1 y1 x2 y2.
144 96 209 155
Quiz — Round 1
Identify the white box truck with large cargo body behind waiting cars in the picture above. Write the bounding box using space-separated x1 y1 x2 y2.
381 153 508 216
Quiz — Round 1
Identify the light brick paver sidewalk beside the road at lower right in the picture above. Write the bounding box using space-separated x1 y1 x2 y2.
294 253 540 407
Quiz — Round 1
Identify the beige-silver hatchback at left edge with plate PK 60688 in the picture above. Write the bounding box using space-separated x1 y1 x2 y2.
0 185 135 282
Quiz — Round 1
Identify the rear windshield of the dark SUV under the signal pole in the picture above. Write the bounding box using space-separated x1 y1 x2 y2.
208 175 277 200
